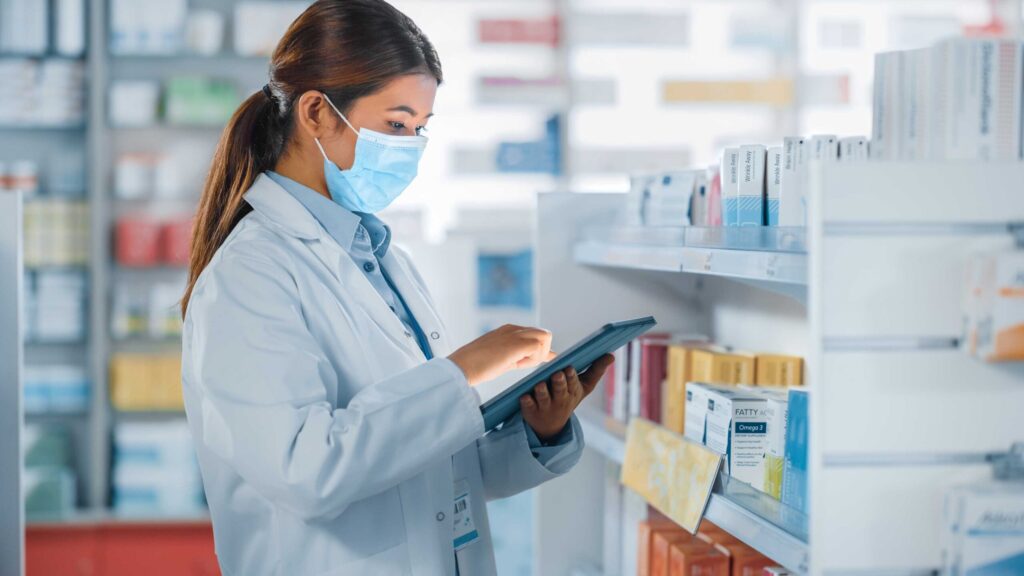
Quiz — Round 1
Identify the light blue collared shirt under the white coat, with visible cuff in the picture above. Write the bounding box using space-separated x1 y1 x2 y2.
266 170 579 467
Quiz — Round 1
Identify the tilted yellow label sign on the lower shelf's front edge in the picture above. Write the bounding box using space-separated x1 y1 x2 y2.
622 418 722 533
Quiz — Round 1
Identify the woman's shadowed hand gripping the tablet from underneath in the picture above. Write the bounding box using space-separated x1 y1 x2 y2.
519 354 614 442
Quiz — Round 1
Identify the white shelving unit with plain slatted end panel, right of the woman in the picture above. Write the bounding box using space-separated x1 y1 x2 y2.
535 158 1024 576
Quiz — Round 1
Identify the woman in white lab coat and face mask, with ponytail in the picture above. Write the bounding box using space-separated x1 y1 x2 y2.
182 0 610 576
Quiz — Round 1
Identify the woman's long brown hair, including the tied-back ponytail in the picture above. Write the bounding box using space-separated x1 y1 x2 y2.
181 0 441 317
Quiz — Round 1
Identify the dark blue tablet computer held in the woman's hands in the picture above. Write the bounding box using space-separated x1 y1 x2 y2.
480 316 657 431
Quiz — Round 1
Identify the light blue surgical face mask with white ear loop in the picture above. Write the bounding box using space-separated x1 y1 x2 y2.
313 94 427 214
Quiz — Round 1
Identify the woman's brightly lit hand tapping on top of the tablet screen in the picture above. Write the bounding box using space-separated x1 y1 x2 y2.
449 324 555 386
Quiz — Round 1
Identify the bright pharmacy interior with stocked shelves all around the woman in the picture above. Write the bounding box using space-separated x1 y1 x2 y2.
0 0 1024 576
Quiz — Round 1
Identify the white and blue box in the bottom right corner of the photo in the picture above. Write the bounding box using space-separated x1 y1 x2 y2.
942 482 1024 576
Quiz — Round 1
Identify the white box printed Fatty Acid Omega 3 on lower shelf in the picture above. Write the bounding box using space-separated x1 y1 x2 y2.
705 387 768 481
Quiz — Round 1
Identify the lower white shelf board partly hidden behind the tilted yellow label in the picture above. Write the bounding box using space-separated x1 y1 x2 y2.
578 411 810 574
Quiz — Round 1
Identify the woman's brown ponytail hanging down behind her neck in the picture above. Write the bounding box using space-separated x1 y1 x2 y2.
181 90 284 318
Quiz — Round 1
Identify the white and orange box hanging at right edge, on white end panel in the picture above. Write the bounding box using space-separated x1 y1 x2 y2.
975 250 1024 362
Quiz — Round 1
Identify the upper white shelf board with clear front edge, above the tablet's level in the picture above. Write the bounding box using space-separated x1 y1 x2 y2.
572 223 807 300
